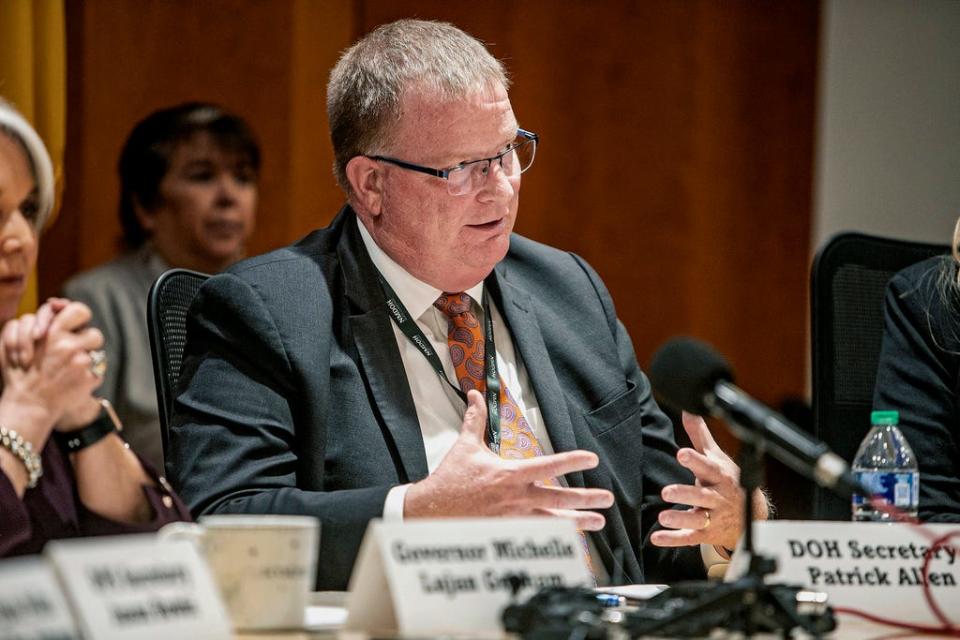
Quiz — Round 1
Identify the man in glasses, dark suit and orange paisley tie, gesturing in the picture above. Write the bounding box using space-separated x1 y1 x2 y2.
169 20 766 589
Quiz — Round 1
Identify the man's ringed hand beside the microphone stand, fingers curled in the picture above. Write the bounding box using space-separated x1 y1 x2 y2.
650 413 769 549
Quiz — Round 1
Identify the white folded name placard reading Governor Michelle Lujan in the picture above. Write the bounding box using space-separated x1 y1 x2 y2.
346 518 592 634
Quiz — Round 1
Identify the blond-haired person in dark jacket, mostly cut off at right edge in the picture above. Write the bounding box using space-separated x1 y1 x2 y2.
873 220 960 522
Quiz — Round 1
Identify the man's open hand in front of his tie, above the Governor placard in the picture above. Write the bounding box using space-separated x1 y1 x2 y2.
403 391 613 531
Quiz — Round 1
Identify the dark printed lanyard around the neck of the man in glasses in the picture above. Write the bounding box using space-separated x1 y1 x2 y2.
377 273 500 455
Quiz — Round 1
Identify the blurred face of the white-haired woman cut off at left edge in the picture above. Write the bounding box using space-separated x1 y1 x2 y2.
0 132 38 323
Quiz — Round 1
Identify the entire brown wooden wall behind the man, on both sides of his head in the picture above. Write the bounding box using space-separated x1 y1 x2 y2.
41 0 819 510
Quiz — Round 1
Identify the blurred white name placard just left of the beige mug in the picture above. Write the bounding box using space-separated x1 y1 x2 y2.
44 534 231 640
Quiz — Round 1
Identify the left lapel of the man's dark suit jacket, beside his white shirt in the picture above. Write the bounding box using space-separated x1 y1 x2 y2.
338 211 427 482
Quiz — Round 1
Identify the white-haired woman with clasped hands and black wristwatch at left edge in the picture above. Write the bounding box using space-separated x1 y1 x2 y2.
0 99 189 557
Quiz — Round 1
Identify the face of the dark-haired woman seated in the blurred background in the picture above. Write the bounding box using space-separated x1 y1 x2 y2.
138 132 257 273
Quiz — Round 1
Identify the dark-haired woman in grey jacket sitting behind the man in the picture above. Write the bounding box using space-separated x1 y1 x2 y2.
64 102 260 468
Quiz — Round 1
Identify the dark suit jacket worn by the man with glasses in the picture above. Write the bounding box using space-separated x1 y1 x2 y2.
167 207 704 589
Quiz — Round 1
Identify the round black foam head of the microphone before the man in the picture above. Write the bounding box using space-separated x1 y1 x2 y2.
650 337 733 416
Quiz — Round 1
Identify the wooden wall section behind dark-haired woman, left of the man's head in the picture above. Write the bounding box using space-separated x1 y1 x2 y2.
41 0 354 295
